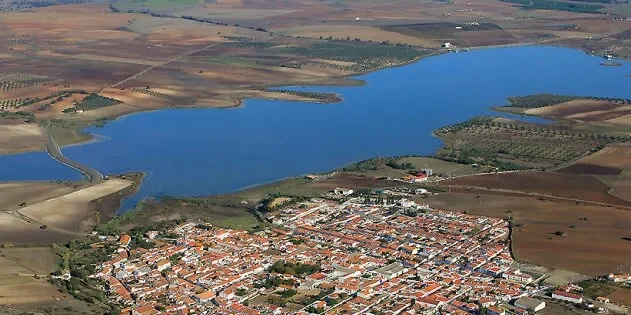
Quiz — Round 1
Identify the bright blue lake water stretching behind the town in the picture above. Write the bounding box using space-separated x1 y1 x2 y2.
0 46 631 209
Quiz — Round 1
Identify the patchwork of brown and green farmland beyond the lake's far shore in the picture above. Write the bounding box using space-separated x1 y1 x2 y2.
0 0 631 158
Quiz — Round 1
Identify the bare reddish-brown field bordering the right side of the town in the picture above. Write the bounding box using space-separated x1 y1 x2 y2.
418 193 631 276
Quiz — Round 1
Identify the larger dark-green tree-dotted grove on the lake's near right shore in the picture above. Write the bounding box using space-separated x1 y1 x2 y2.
435 117 631 170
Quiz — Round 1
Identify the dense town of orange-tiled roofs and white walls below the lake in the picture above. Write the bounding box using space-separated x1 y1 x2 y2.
92 193 612 315
